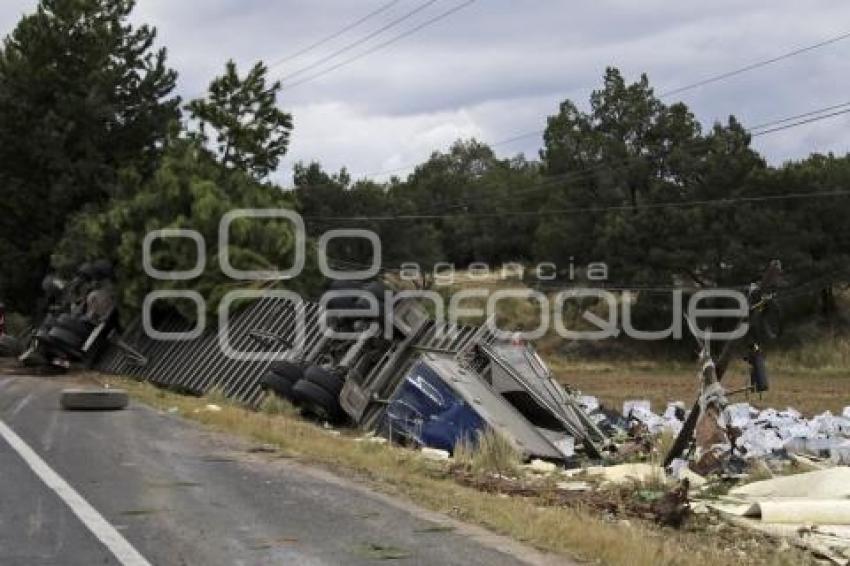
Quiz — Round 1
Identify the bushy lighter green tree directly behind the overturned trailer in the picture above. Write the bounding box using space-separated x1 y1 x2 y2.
53 139 317 318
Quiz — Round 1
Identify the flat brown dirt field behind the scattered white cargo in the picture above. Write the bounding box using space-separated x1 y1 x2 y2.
548 359 850 417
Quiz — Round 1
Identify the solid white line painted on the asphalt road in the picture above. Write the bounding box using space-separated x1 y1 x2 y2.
0 421 151 566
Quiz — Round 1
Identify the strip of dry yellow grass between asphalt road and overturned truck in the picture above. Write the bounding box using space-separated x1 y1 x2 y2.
101 377 808 566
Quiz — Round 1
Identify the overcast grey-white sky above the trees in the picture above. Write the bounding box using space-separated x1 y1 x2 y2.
0 0 850 184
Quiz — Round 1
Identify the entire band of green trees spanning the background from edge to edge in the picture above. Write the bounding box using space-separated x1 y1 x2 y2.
0 0 850 332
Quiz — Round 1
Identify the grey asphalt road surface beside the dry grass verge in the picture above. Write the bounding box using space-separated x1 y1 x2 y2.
0 376 552 566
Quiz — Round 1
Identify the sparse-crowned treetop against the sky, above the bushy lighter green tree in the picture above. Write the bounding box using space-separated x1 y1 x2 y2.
186 61 292 179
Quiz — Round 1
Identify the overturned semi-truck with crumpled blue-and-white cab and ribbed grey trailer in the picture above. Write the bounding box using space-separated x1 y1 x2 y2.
96 282 610 461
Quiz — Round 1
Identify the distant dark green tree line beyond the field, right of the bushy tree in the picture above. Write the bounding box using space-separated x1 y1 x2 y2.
294 68 850 326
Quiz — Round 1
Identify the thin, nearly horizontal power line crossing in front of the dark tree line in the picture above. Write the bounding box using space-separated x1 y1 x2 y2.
304 190 850 222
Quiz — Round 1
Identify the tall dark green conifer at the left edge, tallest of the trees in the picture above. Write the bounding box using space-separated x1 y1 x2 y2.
0 0 179 316
